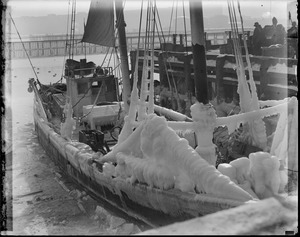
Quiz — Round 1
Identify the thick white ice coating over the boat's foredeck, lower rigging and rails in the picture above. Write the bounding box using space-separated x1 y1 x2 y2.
99 12 298 201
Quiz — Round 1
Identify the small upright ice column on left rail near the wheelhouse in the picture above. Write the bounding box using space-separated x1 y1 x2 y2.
60 99 76 141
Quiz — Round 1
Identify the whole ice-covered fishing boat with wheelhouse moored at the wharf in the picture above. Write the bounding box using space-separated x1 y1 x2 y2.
29 1 298 225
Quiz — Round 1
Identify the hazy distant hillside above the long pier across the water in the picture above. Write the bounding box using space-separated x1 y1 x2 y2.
7 8 288 35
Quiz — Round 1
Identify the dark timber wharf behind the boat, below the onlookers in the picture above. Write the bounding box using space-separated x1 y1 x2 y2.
130 50 298 113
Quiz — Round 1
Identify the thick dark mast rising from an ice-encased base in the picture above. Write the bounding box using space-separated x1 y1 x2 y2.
189 0 209 104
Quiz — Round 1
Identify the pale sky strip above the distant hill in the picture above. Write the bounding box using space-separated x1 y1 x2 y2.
7 0 296 18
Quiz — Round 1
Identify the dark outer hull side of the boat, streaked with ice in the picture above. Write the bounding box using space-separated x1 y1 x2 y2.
34 97 244 227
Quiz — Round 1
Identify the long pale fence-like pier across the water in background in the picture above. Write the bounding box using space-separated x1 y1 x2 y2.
6 29 250 58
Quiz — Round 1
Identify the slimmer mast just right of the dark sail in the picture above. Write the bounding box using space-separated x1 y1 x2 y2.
115 0 131 114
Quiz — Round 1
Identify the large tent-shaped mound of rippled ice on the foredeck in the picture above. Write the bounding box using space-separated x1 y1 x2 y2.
100 114 253 201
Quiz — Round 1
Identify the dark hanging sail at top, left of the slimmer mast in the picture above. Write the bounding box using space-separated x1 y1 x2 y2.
81 0 115 47
